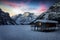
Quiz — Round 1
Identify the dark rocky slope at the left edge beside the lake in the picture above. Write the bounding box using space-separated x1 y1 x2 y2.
0 9 16 25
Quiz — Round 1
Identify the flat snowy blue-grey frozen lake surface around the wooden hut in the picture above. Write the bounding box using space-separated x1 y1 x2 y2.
0 25 60 40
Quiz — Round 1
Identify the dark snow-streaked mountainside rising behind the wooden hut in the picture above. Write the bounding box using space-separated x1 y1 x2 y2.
32 2 60 23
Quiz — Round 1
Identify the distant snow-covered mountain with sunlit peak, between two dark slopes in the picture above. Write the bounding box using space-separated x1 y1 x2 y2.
13 12 37 25
